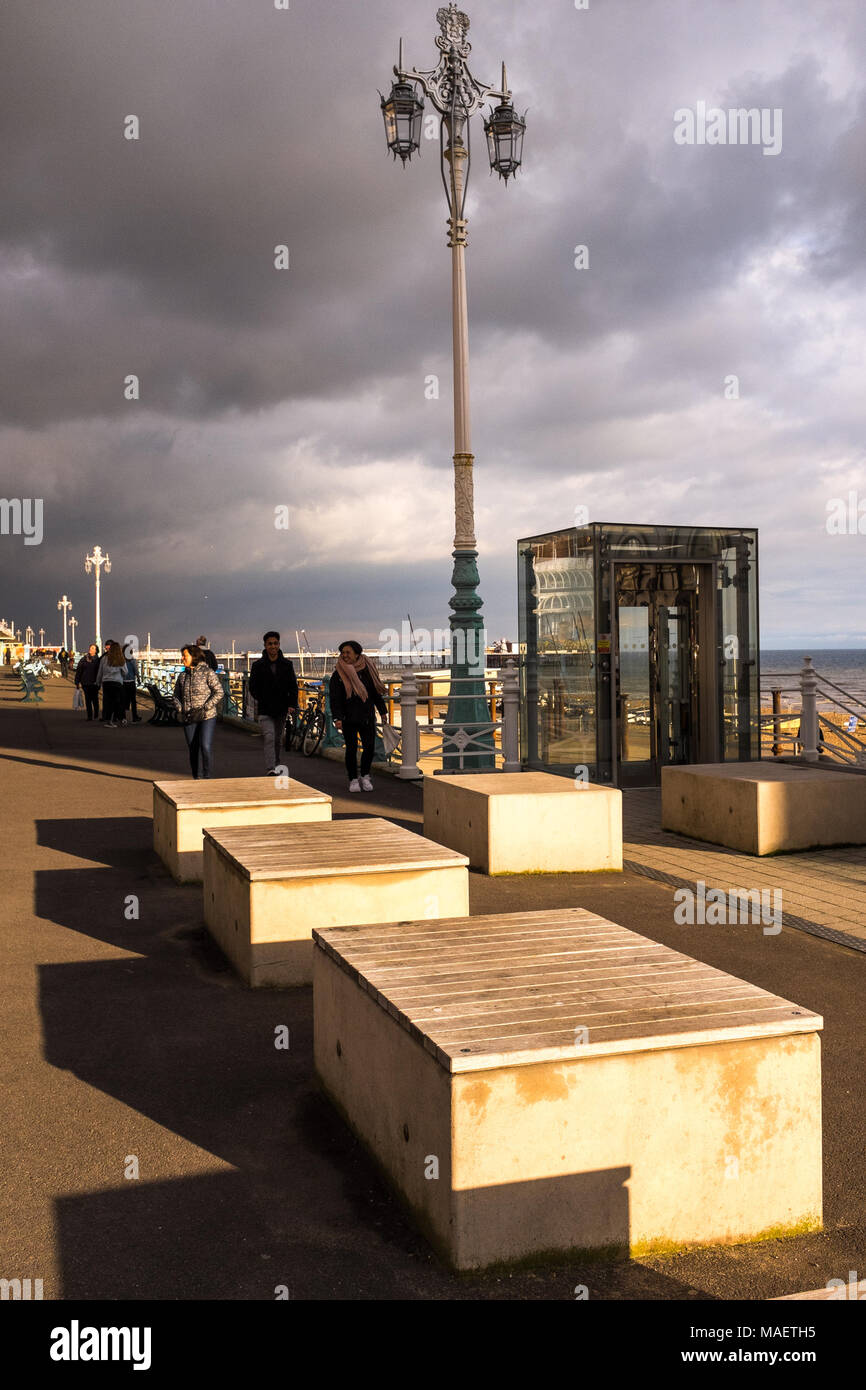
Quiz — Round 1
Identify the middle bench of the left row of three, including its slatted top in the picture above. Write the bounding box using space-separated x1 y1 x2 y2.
204 817 468 986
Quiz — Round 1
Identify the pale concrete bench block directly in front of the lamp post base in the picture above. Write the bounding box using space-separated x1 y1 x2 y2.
424 773 623 874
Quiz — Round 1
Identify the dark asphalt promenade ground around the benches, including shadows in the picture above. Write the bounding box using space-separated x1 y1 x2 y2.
0 673 866 1301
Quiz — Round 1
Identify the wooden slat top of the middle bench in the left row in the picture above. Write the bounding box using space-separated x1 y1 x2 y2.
204 816 468 880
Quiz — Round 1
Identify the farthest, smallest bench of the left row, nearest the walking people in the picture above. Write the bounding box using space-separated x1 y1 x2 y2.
153 777 331 883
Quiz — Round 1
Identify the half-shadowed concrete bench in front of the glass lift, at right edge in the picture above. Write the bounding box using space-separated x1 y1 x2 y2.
662 762 866 855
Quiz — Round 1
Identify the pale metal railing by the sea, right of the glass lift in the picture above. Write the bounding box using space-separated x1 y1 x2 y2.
759 656 866 767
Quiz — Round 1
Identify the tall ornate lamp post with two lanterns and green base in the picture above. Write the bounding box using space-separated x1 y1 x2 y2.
379 3 525 771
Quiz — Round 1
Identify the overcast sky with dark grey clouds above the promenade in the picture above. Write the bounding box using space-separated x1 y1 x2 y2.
0 0 866 646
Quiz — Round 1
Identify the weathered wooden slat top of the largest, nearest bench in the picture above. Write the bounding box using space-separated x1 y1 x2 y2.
313 908 823 1072
